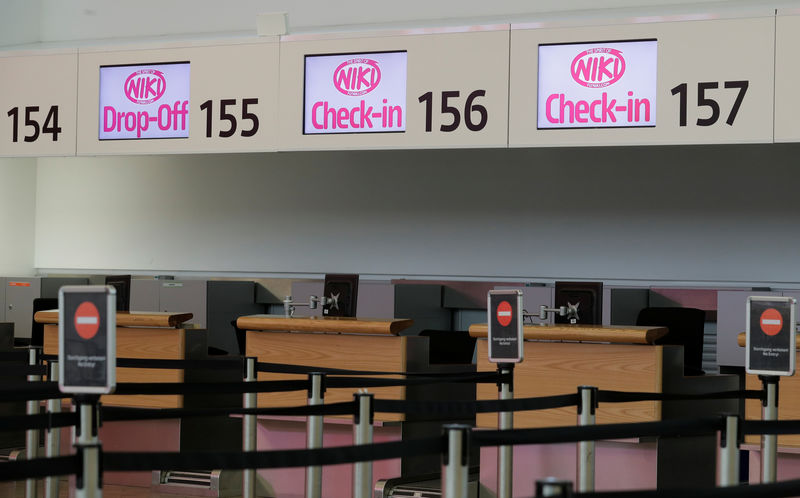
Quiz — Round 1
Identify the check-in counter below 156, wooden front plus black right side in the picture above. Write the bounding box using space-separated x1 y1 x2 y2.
237 315 475 479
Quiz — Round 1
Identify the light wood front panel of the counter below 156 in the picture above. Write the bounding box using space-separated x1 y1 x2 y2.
247 330 406 421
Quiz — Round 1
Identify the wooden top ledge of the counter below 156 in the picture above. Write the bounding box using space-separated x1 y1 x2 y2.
236 315 414 335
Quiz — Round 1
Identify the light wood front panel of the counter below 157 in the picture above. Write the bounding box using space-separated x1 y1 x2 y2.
477 339 662 429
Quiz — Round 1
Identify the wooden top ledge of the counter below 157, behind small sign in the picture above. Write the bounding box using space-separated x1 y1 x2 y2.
469 323 667 344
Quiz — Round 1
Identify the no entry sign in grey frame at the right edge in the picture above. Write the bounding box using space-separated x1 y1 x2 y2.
745 296 797 375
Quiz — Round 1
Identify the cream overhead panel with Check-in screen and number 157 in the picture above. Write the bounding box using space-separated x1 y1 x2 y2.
509 15 775 147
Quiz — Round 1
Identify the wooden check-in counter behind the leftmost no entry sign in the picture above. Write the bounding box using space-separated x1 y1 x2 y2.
34 310 197 408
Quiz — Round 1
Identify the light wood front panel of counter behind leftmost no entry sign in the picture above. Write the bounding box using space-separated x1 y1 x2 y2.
44 324 185 408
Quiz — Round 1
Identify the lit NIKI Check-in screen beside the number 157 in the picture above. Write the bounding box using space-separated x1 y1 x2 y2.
537 40 658 129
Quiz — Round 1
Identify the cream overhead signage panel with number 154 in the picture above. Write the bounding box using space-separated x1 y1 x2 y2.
0 51 78 157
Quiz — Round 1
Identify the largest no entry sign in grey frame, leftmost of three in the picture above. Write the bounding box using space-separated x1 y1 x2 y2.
58 285 117 394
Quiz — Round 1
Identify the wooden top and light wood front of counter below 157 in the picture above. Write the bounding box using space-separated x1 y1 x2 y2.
470 324 668 428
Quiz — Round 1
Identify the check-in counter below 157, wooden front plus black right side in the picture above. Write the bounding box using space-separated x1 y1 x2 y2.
470 324 738 488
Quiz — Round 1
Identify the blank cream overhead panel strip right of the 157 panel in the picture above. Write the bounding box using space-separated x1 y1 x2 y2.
775 10 800 142
